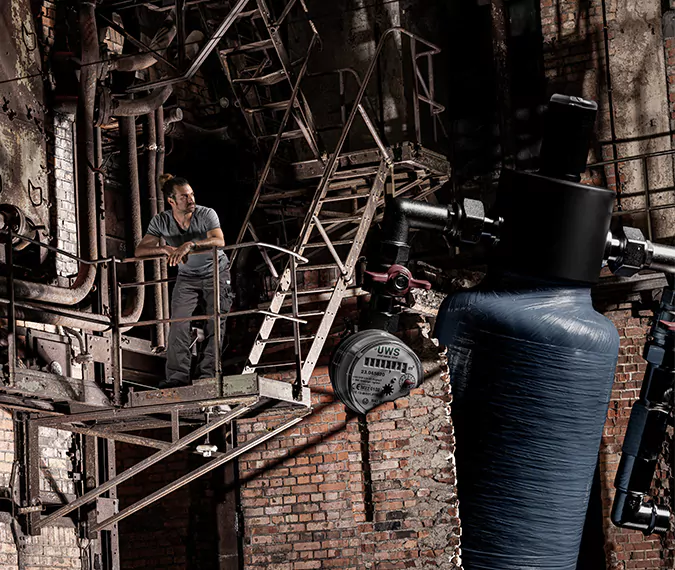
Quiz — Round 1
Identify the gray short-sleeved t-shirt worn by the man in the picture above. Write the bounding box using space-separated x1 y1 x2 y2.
148 206 229 277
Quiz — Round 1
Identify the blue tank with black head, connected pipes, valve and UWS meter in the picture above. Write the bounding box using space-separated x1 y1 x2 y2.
330 95 675 570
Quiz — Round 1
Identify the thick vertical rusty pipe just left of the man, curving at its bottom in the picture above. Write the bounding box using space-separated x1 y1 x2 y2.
120 117 145 324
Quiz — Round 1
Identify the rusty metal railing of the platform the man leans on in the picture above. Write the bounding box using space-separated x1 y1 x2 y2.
0 233 308 406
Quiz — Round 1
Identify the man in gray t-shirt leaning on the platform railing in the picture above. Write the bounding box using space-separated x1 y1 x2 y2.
135 174 233 388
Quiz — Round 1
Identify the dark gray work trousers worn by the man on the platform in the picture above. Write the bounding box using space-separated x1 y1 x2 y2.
166 267 234 384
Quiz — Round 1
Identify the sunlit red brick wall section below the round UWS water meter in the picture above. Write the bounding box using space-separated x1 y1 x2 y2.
240 356 459 570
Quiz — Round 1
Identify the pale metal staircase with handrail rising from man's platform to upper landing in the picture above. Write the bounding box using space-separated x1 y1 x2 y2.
238 28 449 393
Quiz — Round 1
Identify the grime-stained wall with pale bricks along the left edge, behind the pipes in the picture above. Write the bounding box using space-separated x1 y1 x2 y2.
0 0 86 570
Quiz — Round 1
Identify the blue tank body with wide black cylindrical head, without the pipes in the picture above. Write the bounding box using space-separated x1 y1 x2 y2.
435 166 619 570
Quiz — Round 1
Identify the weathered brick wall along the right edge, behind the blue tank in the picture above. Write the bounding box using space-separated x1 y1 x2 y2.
540 0 675 560
